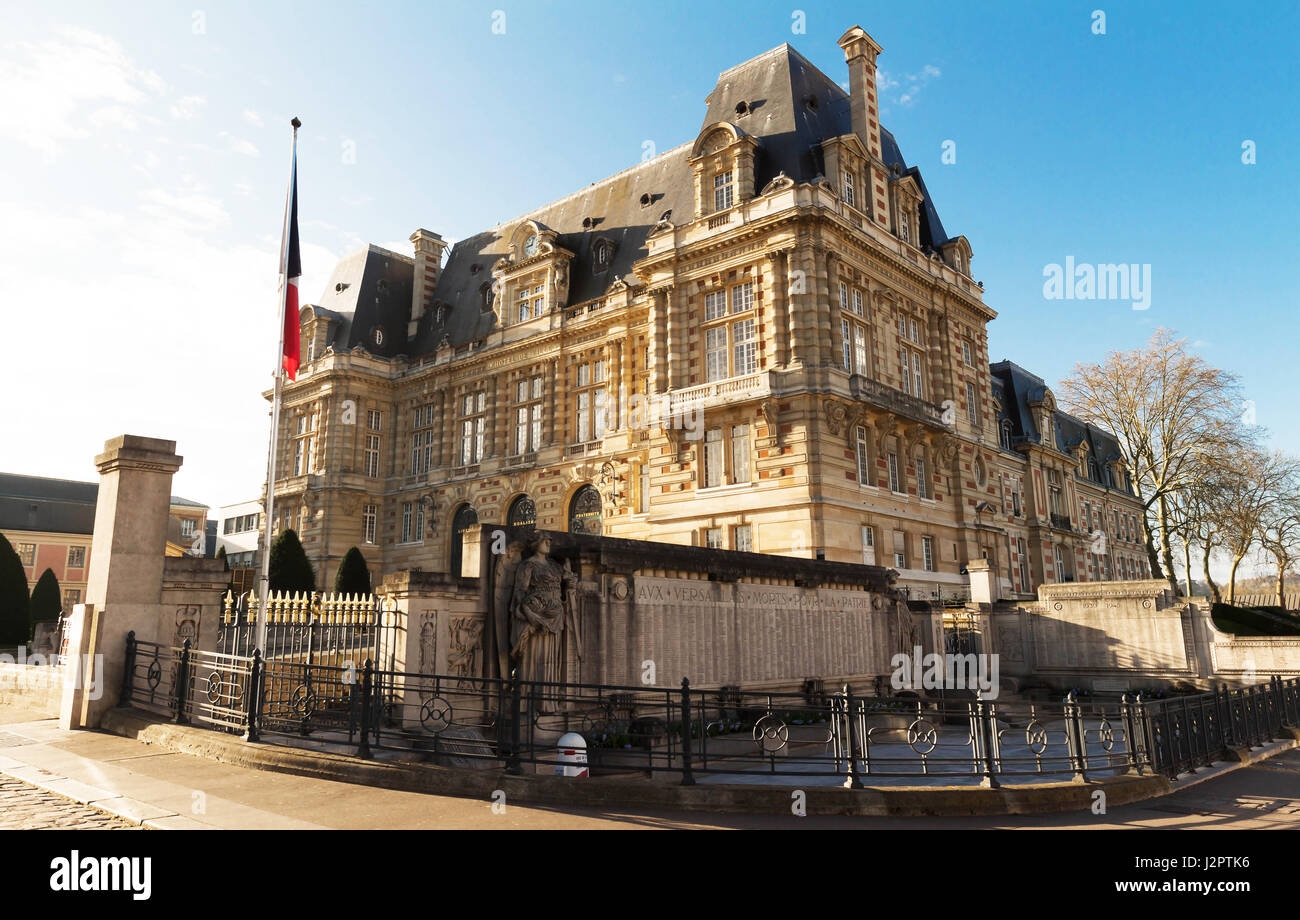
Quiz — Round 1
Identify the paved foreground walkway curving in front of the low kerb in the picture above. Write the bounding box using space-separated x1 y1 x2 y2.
0 712 1300 829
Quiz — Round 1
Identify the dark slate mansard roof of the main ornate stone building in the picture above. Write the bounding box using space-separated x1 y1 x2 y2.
309 44 949 357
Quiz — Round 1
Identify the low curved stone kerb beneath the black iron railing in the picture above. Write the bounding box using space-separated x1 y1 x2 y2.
101 709 1174 816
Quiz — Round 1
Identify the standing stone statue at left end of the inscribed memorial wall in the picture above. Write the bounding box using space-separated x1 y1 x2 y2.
510 534 581 709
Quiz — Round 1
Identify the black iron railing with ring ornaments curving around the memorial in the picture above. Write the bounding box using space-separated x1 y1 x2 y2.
121 634 1300 787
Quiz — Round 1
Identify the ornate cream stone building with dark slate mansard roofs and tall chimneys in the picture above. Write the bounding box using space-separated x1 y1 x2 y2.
266 27 1148 596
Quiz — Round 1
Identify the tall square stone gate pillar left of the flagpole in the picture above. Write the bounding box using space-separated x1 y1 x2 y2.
59 434 181 729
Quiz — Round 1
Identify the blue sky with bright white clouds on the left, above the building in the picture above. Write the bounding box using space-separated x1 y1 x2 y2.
0 0 1300 505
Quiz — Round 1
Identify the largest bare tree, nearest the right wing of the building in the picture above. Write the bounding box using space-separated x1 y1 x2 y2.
1060 329 1256 591
